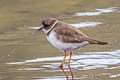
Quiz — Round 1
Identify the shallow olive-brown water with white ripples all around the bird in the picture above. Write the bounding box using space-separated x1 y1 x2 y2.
0 0 120 80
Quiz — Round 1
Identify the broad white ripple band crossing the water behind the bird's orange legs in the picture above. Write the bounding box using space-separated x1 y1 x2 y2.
7 50 120 70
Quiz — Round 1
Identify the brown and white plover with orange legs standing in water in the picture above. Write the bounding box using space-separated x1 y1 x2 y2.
38 17 108 68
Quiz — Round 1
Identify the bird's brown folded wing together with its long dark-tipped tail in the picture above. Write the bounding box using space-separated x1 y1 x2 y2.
55 24 108 45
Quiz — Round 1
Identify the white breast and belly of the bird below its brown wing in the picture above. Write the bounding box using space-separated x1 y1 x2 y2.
47 31 89 51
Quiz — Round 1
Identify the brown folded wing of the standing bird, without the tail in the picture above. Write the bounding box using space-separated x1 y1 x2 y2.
55 22 87 43
